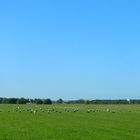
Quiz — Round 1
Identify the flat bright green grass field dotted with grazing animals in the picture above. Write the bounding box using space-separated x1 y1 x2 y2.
0 105 140 140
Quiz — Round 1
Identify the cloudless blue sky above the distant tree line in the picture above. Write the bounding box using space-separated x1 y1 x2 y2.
0 0 140 99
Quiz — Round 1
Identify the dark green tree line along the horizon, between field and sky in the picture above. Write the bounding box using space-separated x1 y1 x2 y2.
0 97 140 104
